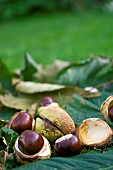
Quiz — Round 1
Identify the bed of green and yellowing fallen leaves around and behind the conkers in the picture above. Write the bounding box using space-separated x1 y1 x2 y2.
0 53 113 170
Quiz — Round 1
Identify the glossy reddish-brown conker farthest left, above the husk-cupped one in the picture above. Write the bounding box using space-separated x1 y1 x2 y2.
9 112 33 134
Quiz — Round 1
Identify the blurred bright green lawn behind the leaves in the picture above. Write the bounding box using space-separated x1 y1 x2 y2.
0 10 113 70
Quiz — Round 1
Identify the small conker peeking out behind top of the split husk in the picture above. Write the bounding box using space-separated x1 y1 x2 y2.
39 96 55 107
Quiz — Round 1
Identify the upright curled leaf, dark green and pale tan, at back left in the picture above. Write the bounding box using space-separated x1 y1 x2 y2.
14 53 70 83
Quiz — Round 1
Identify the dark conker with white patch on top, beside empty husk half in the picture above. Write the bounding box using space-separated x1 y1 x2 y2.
55 134 82 156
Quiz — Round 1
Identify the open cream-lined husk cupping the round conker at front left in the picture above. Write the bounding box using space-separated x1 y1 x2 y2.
14 133 51 164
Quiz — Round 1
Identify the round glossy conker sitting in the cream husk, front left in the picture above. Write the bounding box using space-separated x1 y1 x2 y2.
18 130 44 155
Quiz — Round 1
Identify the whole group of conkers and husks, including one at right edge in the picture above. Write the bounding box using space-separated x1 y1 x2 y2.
7 96 113 163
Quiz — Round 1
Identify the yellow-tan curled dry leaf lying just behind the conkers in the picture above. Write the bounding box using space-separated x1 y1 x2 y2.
0 81 100 111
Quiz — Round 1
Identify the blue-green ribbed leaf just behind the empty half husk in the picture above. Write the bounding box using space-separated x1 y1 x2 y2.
66 89 112 125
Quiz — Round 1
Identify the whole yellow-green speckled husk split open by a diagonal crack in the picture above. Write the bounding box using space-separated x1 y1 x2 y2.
36 102 75 141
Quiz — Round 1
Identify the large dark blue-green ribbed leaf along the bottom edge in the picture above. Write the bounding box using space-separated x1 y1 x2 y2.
14 148 113 170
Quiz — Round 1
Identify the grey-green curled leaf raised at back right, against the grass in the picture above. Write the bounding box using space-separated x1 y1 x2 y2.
57 57 110 86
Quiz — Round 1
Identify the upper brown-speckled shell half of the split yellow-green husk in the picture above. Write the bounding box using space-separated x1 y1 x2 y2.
38 103 75 134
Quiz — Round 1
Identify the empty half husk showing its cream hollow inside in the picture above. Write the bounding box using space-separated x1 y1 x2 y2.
77 118 112 148
